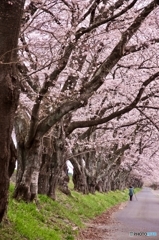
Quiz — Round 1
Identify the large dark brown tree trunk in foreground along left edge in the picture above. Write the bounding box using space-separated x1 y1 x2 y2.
0 0 24 222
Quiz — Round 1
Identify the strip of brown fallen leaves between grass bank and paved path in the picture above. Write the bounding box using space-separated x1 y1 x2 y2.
76 203 126 240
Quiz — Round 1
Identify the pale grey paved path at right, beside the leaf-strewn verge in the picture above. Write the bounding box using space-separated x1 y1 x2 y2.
103 188 159 240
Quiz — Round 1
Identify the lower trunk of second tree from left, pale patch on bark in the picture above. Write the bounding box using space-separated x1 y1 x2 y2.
14 140 41 202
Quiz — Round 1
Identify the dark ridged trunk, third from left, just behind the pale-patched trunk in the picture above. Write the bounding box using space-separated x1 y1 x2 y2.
38 126 70 200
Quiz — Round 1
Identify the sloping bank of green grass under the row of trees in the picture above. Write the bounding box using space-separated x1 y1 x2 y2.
0 185 140 240
